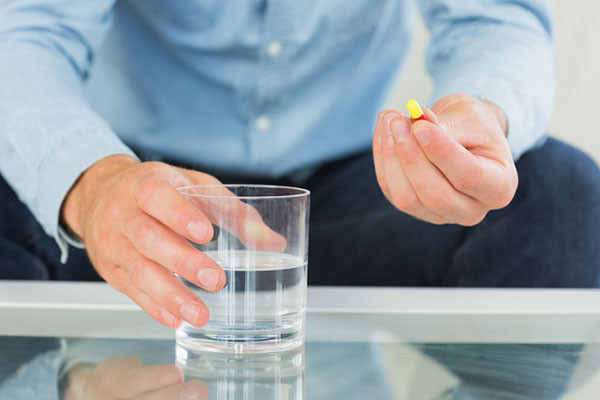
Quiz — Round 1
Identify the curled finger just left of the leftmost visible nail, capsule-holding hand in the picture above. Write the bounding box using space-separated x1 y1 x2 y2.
382 113 445 224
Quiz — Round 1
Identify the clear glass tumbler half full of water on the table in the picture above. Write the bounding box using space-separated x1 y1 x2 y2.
176 185 310 354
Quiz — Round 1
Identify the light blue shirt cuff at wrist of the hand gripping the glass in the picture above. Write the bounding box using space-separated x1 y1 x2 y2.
36 127 140 264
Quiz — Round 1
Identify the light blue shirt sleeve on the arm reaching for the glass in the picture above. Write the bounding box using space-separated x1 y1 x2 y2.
0 0 139 263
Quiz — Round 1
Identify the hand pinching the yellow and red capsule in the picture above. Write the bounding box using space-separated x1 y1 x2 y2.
373 94 518 226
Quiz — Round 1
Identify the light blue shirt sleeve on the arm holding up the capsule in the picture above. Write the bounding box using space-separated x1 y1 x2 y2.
418 0 555 160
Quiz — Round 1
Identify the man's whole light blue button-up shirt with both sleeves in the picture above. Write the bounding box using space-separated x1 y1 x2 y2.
0 0 554 261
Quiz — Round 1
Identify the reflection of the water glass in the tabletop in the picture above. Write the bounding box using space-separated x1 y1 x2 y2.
176 346 305 400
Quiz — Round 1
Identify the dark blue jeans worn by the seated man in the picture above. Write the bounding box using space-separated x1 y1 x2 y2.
0 139 600 287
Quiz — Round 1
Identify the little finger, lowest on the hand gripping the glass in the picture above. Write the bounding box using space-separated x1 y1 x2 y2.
104 266 181 329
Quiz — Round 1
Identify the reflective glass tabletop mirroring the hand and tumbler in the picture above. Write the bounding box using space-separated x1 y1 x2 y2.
0 337 600 400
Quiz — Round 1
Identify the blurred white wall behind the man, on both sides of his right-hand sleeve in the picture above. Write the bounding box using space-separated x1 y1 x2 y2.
391 0 600 162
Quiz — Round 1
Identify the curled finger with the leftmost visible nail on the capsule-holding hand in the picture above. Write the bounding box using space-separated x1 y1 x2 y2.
390 117 485 225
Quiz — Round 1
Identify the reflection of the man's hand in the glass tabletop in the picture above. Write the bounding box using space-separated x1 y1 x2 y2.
65 357 208 400
